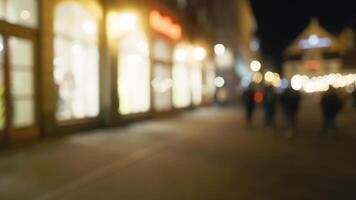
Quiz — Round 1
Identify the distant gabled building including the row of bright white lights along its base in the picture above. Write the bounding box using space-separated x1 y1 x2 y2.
284 18 356 93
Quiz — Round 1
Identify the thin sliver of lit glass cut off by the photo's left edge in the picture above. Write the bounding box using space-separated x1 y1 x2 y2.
0 35 5 130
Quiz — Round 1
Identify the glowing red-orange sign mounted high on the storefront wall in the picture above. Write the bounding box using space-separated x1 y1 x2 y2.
149 10 182 40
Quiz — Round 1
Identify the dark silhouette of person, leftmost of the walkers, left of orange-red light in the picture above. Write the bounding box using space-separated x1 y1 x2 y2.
242 84 256 126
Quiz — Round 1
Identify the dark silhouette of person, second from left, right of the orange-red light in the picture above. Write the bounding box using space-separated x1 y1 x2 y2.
263 85 278 127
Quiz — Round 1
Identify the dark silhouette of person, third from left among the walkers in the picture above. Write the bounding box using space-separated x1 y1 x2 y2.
280 87 301 136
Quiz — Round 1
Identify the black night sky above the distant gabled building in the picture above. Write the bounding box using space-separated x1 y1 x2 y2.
251 0 356 63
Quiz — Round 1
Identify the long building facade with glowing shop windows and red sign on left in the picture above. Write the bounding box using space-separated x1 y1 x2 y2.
0 0 215 143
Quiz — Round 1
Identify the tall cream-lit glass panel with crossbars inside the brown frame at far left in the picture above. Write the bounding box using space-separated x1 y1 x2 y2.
9 37 35 128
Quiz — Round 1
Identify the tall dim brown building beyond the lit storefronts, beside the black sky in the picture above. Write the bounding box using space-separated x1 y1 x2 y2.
210 0 260 101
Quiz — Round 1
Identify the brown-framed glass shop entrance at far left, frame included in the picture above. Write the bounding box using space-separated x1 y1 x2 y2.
0 30 38 142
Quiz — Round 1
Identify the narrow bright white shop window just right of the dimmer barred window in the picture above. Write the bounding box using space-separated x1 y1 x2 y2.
172 45 191 108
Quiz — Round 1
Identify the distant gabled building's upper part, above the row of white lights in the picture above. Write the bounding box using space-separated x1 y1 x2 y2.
284 18 356 79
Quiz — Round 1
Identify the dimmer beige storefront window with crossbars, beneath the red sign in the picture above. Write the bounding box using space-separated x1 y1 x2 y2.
152 38 173 111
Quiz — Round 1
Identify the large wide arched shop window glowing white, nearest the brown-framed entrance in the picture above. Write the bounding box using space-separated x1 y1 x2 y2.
53 2 99 120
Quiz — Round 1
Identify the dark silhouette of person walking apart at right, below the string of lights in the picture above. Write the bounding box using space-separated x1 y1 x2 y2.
320 88 343 134
